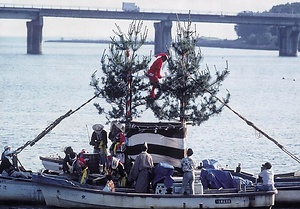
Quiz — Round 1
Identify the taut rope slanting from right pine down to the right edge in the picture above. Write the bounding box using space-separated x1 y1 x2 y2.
206 90 300 163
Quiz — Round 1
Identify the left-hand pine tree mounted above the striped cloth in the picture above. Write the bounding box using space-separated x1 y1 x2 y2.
90 20 150 123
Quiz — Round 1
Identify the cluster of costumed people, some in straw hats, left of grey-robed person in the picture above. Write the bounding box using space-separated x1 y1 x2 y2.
63 122 128 185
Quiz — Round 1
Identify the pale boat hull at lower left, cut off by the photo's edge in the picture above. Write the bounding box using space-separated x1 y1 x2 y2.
0 174 45 205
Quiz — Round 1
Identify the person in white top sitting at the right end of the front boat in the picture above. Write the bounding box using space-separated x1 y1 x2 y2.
255 162 275 191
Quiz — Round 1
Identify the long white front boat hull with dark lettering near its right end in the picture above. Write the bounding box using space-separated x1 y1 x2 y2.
33 171 277 209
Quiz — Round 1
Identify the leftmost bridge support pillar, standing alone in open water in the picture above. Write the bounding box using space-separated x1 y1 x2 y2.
26 17 43 54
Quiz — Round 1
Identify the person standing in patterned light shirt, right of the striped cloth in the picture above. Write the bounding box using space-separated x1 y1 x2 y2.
181 148 196 194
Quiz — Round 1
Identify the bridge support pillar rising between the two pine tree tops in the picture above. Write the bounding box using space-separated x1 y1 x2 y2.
154 20 172 54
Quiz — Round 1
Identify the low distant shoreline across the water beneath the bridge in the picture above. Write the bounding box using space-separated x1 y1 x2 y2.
45 38 278 50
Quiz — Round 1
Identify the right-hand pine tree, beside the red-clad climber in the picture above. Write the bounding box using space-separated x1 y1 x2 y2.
147 18 230 125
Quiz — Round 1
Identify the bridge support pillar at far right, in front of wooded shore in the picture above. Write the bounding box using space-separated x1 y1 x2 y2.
279 26 300 57
